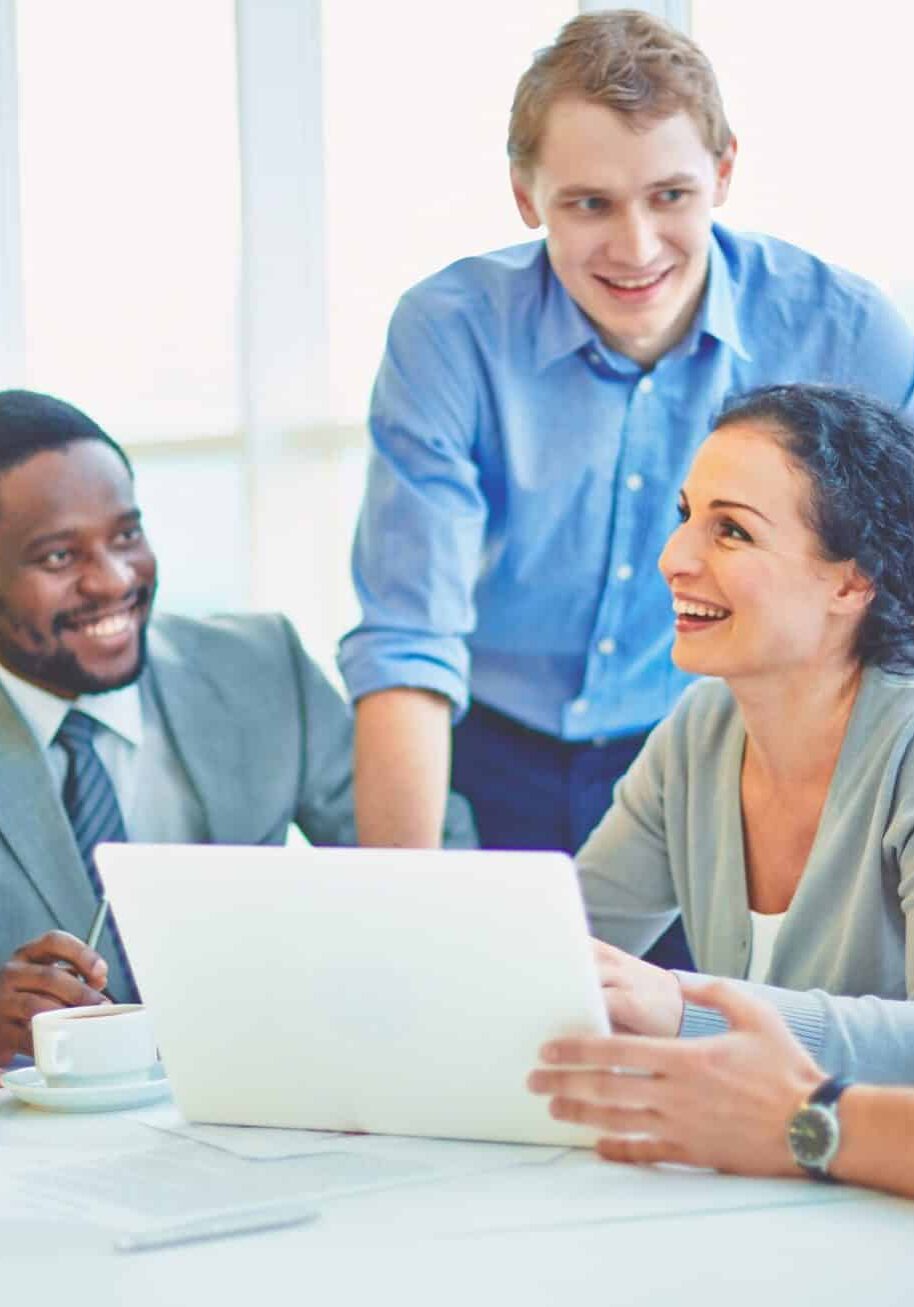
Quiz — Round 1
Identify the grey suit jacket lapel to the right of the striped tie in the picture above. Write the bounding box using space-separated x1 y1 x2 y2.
144 626 250 844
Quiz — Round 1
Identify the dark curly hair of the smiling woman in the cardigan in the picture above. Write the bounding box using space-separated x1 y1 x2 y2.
717 384 914 673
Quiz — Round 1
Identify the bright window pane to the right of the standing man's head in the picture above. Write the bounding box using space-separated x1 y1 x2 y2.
692 0 914 322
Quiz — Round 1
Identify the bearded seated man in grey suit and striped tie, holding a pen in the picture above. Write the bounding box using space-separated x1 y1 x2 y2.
0 391 473 1064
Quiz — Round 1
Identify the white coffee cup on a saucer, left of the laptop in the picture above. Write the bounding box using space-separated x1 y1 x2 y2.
31 1002 157 1089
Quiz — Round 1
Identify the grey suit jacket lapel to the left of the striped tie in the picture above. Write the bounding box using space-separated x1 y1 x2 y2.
0 690 95 935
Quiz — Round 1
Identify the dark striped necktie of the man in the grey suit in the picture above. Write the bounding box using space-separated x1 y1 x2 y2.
55 708 139 1002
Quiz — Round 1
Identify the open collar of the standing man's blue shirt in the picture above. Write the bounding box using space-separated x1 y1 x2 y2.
536 230 752 371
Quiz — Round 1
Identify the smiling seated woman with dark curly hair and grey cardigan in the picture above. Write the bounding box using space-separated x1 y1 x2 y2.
578 386 914 1081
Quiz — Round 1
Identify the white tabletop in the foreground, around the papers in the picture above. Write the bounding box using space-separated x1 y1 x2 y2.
0 1091 914 1307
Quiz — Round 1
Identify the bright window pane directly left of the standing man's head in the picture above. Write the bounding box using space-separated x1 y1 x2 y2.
323 0 578 420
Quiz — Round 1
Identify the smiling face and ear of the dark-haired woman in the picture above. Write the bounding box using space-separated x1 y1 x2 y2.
660 406 872 689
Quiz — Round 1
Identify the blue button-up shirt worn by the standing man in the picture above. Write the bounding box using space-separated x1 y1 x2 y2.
340 226 914 740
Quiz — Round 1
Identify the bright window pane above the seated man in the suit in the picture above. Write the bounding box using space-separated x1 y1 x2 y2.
17 0 239 440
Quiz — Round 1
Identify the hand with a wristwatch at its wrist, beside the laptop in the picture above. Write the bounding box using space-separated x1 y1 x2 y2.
528 980 825 1175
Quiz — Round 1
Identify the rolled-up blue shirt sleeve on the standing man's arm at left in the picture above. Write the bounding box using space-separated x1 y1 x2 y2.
340 293 486 712
